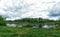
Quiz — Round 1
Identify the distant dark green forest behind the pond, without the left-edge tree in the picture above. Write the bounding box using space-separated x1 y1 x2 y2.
8 18 60 25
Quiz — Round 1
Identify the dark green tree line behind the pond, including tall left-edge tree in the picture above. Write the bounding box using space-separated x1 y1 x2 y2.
0 16 60 26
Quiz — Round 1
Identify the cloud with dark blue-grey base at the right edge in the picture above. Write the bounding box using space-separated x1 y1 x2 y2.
50 2 60 17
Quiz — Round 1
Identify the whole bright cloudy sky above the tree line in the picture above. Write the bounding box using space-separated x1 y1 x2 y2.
0 0 60 20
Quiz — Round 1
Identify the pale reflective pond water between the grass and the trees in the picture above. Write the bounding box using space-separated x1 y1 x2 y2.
7 24 58 28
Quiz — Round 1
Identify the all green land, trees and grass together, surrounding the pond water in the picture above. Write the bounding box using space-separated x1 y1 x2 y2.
0 16 60 37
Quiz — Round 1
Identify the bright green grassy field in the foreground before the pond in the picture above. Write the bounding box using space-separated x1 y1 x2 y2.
0 26 60 37
